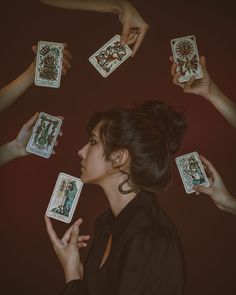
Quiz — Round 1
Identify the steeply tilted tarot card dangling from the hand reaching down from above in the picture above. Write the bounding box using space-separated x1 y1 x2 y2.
89 35 132 78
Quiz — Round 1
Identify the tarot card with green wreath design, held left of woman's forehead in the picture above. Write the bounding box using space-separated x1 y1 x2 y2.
26 112 62 158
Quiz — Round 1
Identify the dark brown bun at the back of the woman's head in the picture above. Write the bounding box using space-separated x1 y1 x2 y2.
138 100 187 155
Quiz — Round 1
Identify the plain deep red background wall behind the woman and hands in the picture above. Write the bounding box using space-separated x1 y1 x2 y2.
0 0 236 295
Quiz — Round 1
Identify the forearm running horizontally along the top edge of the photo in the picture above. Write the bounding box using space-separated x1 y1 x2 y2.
40 0 127 14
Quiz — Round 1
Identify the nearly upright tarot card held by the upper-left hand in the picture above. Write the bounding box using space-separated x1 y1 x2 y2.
34 41 64 88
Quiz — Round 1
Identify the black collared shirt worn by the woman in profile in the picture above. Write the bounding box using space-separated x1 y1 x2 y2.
63 191 184 295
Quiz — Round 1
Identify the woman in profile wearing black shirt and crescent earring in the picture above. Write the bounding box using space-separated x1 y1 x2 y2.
45 101 186 295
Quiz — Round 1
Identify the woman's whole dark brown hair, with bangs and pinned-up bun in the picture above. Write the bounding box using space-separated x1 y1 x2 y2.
85 100 187 192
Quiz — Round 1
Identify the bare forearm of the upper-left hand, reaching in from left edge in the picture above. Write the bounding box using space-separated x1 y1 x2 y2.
0 66 34 111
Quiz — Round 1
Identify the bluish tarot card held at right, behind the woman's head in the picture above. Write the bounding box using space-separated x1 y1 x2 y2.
175 152 210 194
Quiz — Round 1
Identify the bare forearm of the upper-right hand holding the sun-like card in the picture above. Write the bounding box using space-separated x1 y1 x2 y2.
205 83 236 128
